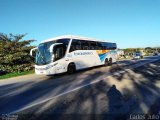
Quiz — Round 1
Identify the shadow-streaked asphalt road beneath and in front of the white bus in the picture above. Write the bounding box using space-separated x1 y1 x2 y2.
0 56 160 118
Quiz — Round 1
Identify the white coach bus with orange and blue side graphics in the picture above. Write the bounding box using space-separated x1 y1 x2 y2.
30 35 117 75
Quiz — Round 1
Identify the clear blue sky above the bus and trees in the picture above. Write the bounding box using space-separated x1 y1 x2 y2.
0 0 160 48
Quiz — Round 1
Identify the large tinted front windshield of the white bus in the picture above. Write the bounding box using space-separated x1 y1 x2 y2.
35 39 69 65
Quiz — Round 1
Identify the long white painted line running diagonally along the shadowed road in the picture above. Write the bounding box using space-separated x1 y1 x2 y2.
9 58 160 114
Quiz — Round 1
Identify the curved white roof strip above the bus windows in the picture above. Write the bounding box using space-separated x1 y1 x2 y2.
41 35 113 43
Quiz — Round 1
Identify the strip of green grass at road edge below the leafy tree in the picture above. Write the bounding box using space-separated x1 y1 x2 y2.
0 70 34 79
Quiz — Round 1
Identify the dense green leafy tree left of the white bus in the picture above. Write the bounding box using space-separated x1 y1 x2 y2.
0 33 35 73
